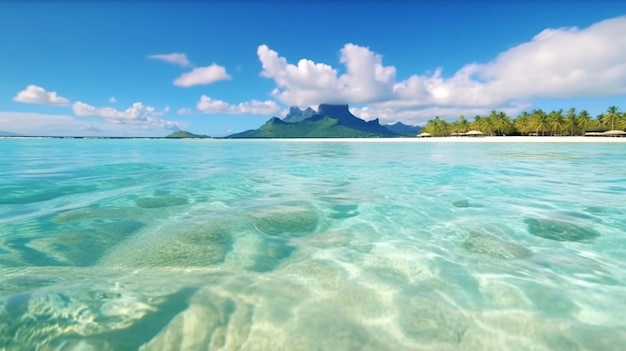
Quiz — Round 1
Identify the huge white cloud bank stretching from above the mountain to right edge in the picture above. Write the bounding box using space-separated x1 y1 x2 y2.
257 16 626 122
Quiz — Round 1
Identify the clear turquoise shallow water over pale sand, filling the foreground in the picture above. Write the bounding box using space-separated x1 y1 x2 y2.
0 139 626 350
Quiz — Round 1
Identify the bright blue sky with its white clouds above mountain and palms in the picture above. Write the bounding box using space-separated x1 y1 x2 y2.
0 0 626 137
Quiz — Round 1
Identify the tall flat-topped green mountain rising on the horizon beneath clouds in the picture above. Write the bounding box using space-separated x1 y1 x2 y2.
227 104 398 138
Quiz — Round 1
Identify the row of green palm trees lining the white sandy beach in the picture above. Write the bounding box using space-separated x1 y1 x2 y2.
422 106 626 136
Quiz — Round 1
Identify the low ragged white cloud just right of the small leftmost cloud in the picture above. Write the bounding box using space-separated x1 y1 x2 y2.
72 101 181 130
